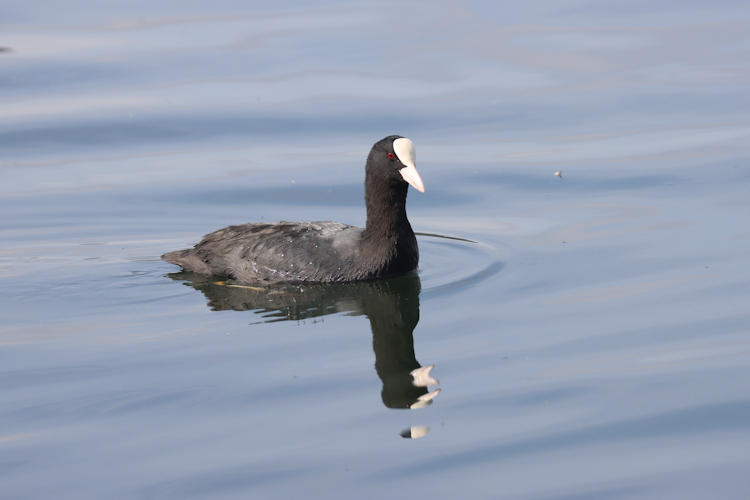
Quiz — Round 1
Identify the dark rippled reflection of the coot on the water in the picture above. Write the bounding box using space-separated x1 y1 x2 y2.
168 272 440 438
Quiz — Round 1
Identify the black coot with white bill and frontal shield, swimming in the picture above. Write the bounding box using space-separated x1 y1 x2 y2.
162 135 424 284
